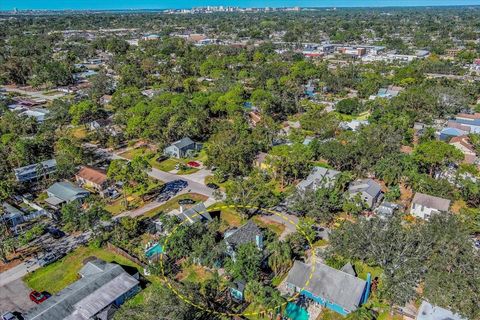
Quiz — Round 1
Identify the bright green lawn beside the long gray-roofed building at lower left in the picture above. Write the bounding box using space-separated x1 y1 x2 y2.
23 246 141 294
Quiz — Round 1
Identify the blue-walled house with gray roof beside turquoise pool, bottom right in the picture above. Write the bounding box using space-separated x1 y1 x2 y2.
285 261 370 316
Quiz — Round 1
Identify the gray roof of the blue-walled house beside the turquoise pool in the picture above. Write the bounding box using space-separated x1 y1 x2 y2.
286 261 367 311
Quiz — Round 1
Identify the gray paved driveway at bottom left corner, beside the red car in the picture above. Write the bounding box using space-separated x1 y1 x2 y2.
0 279 36 314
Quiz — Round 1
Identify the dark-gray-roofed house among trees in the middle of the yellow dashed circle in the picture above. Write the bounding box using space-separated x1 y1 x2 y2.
223 220 263 260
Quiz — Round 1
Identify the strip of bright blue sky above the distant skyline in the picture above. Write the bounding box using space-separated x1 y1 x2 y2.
0 0 480 10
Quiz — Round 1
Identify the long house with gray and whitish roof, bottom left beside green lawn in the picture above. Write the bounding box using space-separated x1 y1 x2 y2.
24 259 141 320
